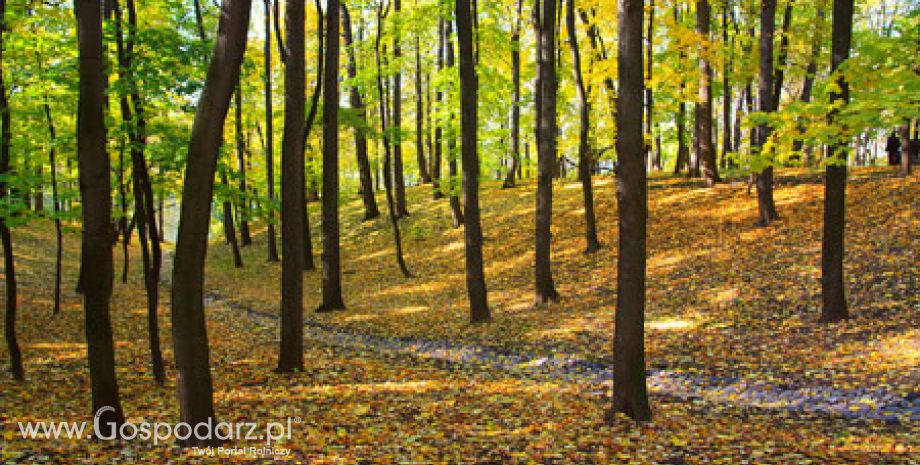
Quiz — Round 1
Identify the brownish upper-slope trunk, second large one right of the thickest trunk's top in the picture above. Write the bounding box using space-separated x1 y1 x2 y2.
696 0 721 186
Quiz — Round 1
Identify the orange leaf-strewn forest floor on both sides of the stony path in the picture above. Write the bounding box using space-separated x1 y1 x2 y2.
0 169 920 464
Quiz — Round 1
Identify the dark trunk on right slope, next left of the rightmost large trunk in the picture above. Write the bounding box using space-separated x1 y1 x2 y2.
755 0 779 226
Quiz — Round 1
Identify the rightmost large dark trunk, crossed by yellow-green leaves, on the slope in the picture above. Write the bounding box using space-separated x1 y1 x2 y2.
821 0 853 322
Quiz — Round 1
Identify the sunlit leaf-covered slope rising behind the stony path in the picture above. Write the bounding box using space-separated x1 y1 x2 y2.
207 168 920 394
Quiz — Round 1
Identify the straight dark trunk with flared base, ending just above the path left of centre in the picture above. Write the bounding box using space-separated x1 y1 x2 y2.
317 0 345 312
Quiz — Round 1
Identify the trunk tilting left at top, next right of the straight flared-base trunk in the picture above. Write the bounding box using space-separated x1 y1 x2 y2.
342 3 380 221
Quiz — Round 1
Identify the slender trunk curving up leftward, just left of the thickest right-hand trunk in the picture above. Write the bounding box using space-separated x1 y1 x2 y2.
565 0 600 253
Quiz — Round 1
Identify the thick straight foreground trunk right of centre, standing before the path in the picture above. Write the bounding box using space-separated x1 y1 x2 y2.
607 0 652 424
